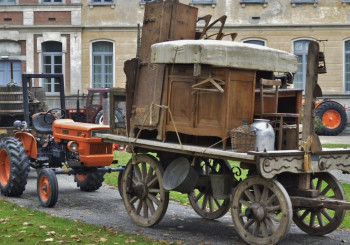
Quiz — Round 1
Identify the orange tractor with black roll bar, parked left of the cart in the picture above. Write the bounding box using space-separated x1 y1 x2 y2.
0 74 124 207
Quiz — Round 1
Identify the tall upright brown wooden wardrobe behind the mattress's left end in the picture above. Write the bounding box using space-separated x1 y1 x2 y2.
130 1 198 131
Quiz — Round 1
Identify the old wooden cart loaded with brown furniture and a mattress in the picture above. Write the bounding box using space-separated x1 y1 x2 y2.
102 0 350 244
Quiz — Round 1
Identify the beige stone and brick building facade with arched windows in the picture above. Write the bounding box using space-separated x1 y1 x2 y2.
0 0 350 112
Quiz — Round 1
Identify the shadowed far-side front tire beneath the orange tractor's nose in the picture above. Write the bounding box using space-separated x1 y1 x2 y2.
74 172 105 192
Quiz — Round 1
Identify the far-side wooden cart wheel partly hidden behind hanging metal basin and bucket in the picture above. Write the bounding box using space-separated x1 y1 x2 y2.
188 159 230 219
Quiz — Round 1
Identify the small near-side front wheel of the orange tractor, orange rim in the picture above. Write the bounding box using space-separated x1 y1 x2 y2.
37 168 58 208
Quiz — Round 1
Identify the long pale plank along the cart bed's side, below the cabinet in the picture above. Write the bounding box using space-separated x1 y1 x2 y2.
96 134 256 163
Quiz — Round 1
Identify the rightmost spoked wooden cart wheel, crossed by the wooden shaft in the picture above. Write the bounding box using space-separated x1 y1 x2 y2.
293 173 346 236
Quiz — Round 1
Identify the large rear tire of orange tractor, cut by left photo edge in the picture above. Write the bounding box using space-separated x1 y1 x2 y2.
0 137 30 197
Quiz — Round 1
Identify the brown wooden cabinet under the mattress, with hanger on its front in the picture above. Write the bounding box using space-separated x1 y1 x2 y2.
163 65 255 147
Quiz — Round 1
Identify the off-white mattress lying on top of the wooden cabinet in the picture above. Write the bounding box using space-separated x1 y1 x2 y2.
151 40 297 73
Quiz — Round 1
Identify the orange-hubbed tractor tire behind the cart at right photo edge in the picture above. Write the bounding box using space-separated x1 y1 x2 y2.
316 101 347 136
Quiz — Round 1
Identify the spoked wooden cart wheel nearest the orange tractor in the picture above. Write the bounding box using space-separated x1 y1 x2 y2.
121 154 169 227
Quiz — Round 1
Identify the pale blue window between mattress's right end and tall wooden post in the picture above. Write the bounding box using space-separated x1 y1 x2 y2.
294 40 310 89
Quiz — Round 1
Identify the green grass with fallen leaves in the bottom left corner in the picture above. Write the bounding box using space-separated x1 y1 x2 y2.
0 199 168 245
